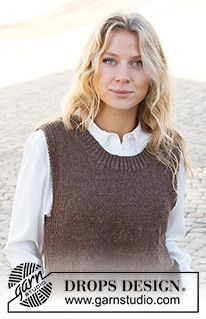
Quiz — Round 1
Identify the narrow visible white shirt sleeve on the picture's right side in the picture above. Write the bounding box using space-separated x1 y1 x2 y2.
166 161 191 271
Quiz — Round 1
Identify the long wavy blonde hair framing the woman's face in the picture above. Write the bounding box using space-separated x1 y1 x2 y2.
62 12 192 190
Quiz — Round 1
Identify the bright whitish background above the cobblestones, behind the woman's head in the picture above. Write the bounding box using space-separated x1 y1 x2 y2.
0 0 206 87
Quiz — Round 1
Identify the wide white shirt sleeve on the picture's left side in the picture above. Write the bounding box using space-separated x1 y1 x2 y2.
4 130 52 268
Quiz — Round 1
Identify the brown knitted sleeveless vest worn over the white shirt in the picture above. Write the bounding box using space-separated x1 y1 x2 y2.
36 118 179 271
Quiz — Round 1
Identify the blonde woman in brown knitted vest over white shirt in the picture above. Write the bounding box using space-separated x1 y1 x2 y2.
5 13 190 272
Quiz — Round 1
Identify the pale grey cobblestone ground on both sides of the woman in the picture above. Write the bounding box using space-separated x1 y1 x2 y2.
0 73 206 298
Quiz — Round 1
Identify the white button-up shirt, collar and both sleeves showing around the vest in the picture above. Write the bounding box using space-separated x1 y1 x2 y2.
4 119 191 271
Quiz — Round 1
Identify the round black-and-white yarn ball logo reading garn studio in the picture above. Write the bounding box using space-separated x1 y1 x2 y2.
8 263 52 307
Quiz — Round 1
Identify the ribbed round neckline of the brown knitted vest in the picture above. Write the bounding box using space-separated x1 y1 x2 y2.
71 130 151 171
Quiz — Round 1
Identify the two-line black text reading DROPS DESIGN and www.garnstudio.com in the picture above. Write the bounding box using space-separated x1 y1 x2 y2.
65 280 181 307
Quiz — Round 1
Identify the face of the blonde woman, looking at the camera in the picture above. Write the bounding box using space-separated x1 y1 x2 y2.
94 30 149 110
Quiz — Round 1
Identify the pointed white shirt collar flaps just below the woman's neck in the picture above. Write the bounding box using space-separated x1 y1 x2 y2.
88 118 150 145
